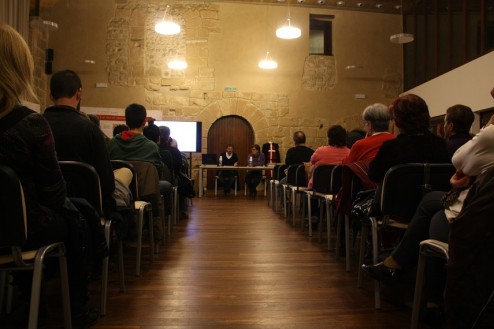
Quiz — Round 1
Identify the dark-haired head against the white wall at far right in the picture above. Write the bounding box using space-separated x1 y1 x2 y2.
444 104 475 157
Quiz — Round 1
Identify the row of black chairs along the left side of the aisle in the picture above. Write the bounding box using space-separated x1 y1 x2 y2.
0 160 178 328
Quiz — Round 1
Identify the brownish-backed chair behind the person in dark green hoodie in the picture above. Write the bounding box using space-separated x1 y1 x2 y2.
117 160 158 276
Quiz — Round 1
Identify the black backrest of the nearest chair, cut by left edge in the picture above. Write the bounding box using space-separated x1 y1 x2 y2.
0 164 27 246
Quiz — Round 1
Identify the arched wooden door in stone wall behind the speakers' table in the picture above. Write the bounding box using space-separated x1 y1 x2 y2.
207 115 254 191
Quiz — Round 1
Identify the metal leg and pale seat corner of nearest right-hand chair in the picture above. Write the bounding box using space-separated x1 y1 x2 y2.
410 239 449 329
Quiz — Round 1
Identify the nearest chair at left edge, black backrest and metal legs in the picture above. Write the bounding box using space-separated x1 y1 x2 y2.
0 165 72 329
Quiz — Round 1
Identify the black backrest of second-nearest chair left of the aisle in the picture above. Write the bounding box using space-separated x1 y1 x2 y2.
58 161 103 216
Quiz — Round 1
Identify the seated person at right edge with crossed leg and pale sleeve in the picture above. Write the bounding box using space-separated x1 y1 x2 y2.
362 97 494 324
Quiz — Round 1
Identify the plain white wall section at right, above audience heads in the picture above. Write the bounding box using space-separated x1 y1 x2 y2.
406 51 494 117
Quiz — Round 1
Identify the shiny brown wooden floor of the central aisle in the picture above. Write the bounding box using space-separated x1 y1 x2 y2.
9 195 432 329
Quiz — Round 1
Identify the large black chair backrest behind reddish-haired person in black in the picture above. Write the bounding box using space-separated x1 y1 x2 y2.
380 163 455 222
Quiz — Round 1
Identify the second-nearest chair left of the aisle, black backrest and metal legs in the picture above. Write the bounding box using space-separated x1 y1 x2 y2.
58 161 119 315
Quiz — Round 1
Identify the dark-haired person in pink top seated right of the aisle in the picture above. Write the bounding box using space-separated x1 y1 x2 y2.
308 125 350 189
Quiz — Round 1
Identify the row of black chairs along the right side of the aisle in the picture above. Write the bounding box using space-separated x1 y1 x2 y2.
270 163 455 328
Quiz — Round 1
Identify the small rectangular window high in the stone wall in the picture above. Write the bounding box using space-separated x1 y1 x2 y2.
309 15 334 56
